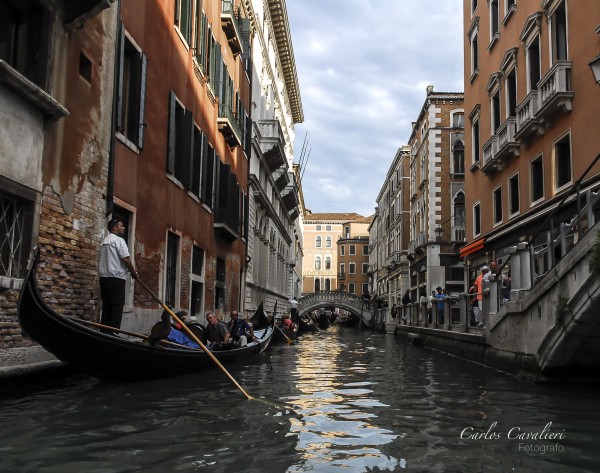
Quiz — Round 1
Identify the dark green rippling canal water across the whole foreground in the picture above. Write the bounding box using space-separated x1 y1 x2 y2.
0 327 600 473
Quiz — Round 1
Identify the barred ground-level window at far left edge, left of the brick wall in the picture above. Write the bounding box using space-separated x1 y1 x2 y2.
0 185 35 278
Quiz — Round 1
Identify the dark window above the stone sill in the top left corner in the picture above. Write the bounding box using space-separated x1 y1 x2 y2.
0 0 50 89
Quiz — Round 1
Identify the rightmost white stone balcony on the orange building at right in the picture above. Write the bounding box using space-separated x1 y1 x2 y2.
538 61 573 123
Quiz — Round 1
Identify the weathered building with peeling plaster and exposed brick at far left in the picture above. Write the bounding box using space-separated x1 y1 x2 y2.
0 0 117 370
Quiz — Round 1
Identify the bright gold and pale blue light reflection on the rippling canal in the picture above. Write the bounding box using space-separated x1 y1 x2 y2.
286 339 405 473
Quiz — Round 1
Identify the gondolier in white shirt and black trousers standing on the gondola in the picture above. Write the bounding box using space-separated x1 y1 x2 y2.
98 219 137 328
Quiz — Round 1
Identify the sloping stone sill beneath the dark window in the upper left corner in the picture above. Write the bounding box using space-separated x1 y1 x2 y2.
0 59 69 122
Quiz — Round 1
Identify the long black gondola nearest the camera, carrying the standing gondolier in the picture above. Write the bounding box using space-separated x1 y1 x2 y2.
18 252 275 381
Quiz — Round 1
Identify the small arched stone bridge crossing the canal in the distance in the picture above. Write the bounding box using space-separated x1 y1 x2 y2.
298 291 376 327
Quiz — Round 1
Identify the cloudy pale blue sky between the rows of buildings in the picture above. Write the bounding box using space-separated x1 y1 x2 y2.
286 0 464 217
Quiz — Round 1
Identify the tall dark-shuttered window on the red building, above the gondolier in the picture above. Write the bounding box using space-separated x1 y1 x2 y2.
117 28 148 148
